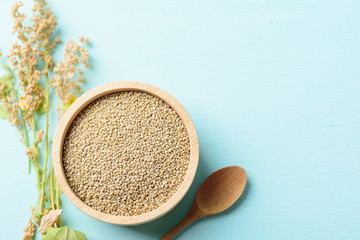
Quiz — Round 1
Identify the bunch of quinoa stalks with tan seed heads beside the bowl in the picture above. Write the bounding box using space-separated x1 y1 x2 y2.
0 0 90 239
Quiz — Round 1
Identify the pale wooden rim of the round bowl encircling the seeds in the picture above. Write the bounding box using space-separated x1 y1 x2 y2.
52 81 199 225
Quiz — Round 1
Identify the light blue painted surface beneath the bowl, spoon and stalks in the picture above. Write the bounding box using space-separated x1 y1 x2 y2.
0 0 360 240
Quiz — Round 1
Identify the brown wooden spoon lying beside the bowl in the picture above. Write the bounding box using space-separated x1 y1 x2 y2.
160 166 247 240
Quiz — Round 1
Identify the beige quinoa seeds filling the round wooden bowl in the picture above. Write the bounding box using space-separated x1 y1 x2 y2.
63 91 190 216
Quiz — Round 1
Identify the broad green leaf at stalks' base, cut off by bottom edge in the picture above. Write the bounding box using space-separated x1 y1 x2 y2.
41 226 87 240
